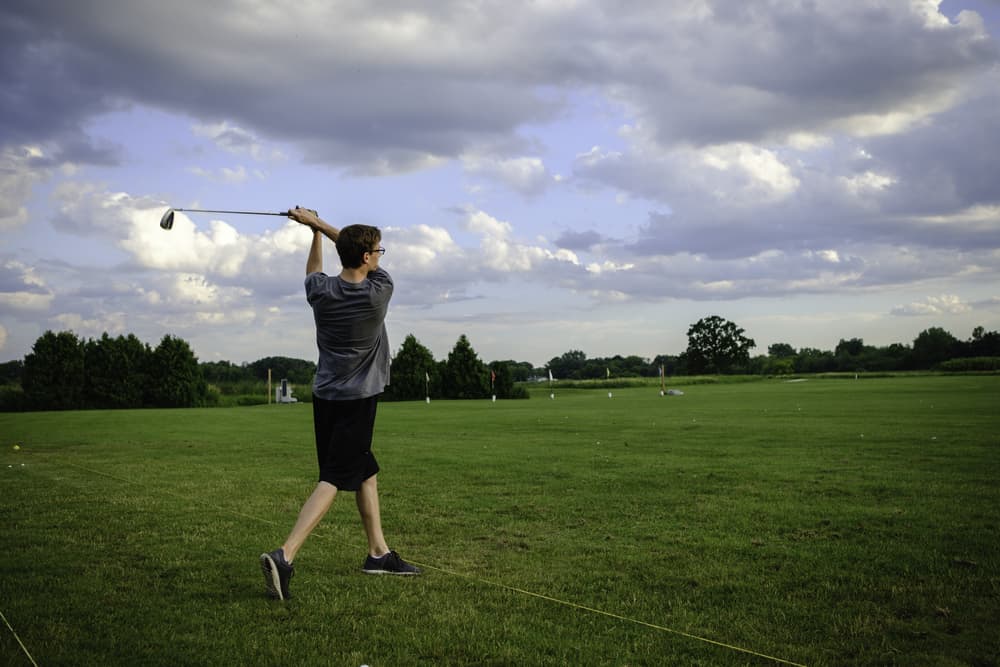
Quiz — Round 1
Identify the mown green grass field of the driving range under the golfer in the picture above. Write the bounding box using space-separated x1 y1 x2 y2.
0 376 1000 667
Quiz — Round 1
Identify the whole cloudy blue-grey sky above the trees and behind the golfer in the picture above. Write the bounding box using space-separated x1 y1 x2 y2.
0 0 1000 365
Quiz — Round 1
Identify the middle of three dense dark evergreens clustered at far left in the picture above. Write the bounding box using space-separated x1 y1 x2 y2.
84 332 152 408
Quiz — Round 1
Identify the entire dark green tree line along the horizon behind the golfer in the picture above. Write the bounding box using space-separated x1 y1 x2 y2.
0 315 1000 411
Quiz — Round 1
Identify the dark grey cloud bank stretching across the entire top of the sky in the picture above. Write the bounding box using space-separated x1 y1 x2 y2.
0 0 996 171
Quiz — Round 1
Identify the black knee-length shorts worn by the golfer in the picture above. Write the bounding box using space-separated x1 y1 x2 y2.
313 395 378 491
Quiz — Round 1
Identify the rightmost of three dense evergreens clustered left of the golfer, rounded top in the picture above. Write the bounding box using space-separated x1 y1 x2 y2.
148 335 208 408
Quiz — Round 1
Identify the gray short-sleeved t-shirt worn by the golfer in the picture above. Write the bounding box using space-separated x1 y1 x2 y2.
305 268 393 401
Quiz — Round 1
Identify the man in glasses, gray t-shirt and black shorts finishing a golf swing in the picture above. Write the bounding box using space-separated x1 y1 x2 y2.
260 207 420 600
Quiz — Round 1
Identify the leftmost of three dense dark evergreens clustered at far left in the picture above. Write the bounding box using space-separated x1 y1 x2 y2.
22 331 85 410
